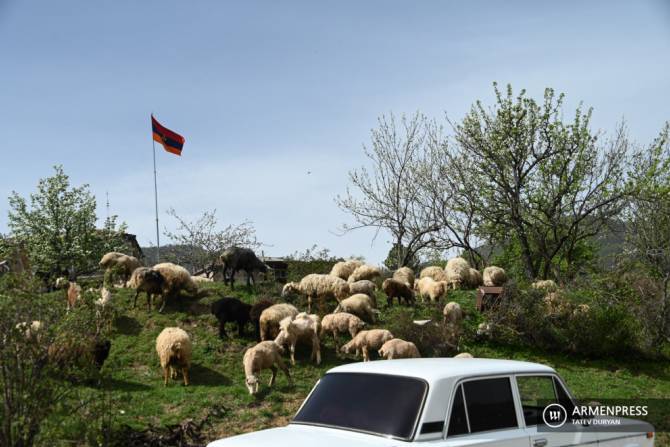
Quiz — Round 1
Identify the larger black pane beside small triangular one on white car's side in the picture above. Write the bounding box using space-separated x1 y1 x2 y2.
463 377 519 433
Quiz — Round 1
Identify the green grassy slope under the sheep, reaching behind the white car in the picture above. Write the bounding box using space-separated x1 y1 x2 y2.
43 284 670 445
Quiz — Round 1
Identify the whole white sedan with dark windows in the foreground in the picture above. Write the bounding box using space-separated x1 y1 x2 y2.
209 358 654 447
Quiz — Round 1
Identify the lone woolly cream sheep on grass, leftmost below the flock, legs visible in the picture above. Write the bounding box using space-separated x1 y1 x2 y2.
156 327 193 386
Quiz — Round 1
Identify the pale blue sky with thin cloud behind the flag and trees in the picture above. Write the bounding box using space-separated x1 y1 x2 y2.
0 0 670 262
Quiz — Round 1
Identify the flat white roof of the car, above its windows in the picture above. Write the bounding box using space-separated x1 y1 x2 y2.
327 358 555 383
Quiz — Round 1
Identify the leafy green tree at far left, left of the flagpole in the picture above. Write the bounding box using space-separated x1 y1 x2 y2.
9 166 125 277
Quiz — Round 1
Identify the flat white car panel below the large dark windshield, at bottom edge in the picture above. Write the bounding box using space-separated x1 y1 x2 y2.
208 424 404 447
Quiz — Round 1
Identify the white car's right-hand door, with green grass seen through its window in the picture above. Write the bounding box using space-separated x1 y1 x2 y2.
515 374 598 447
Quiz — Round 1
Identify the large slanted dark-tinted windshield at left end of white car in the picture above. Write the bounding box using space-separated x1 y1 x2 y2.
293 373 428 440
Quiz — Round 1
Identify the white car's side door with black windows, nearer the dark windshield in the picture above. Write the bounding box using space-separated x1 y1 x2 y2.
439 376 530 447
